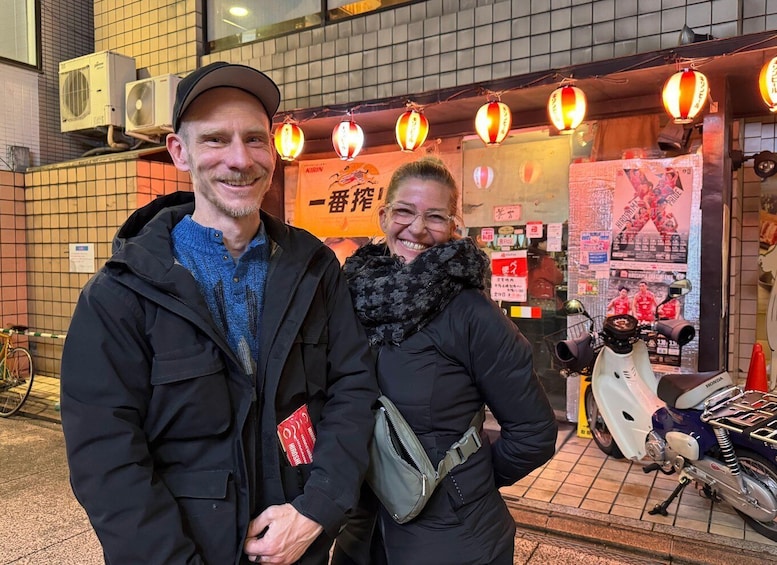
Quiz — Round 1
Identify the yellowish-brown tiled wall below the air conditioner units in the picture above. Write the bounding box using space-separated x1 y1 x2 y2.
17 153 190 375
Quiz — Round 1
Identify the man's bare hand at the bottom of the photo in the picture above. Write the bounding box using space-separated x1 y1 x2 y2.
243 504 324 565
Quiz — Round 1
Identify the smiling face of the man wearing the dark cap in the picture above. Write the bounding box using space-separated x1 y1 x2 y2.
167 88 276 225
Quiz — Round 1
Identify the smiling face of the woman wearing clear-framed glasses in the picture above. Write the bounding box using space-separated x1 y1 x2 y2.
379 177 456 263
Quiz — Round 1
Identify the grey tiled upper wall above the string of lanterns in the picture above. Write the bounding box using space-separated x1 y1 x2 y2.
203 0 756 114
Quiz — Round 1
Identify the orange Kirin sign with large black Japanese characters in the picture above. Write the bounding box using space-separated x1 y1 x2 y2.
294 153 415 237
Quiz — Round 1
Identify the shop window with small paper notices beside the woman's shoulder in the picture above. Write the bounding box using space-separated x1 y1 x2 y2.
462 123 597 412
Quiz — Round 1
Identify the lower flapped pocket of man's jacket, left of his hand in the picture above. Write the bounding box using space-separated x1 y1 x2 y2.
162 470 236 563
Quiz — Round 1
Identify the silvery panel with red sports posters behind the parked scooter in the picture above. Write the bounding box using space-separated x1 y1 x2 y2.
569 155 702 372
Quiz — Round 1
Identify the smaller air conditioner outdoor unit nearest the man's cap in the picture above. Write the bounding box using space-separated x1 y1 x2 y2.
125 75 181 136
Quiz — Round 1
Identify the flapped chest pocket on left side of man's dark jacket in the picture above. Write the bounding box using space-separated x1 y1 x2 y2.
147 344 232 439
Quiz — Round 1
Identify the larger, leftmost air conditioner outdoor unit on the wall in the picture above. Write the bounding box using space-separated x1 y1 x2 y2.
59 51 137 132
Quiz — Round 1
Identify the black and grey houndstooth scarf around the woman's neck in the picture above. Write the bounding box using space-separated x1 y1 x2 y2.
343 238 488 345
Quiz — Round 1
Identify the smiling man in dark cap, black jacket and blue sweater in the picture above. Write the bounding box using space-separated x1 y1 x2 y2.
61 63 378 565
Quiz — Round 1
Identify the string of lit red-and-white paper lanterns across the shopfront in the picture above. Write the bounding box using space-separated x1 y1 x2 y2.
275 57 777 161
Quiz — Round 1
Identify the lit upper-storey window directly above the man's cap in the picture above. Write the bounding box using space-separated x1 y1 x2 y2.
205 0 412 51
